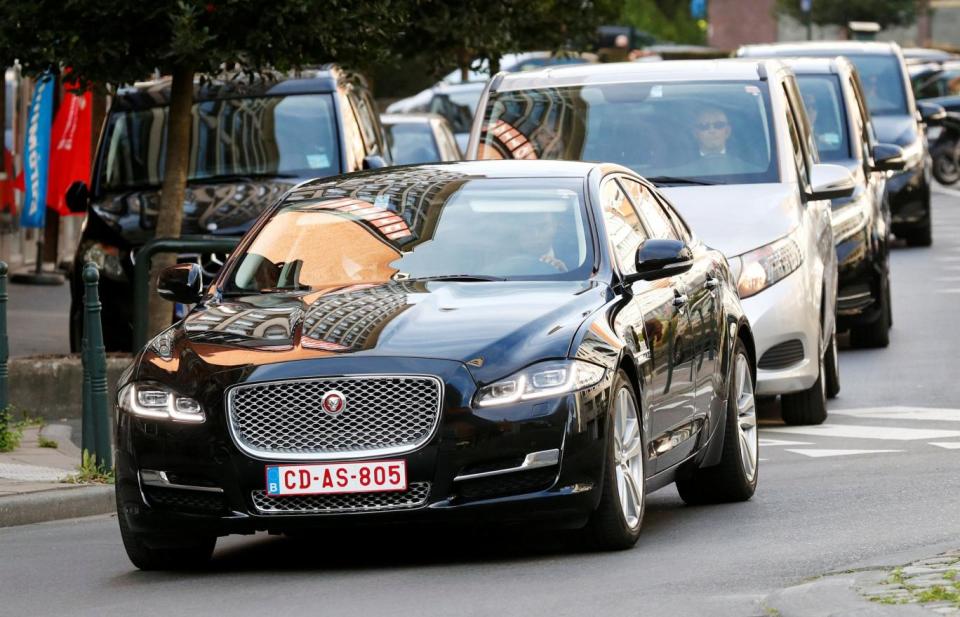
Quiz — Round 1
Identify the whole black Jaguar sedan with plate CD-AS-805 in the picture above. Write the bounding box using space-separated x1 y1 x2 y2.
116 161 757 569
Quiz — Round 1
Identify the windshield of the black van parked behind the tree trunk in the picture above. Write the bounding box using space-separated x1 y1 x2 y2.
100 94 340 190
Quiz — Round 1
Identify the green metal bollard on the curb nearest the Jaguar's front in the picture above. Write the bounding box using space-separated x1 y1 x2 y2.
83 263 113 471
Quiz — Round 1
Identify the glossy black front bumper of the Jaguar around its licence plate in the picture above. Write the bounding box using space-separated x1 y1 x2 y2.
116 359 612 535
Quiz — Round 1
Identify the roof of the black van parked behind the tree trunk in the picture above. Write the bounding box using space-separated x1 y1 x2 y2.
110 66 356 111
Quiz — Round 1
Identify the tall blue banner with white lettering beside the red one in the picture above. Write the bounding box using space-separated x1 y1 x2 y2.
20 73 56 228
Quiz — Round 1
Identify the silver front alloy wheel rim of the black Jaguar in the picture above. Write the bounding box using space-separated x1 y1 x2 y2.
613 388 644 529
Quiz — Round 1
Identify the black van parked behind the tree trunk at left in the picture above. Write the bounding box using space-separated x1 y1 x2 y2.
67 67 390 351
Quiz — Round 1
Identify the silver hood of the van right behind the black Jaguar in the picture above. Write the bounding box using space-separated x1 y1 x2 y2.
660 183 800 257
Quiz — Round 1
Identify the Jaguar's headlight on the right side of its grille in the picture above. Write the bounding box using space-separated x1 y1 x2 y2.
476 360 606 407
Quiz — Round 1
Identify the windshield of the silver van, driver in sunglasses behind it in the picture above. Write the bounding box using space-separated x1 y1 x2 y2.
478 82 779 184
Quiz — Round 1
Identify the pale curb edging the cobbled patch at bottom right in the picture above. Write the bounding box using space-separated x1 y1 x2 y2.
763 570 931 617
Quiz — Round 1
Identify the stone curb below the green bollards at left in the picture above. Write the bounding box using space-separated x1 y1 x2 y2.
0 485 116 527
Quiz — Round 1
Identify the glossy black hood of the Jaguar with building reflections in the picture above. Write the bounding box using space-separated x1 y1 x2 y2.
140 281 610 381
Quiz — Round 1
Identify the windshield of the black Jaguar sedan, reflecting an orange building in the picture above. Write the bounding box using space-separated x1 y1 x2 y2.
223 167 593 293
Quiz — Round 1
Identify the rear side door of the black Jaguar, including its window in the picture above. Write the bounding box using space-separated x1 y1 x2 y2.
619 176 711 469
